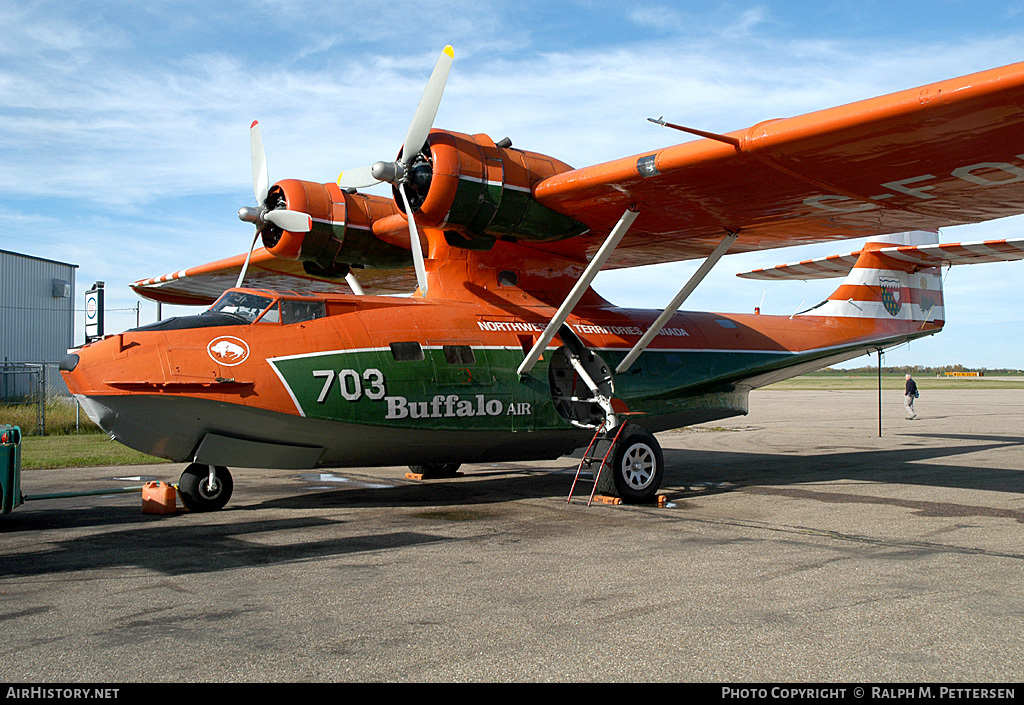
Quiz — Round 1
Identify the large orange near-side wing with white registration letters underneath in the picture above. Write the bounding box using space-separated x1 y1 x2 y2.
535 63 1024 266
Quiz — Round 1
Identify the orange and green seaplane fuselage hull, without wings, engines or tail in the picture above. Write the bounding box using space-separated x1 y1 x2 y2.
65 282 938 467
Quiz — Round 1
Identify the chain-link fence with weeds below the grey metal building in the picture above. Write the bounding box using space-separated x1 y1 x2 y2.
0 362 98 436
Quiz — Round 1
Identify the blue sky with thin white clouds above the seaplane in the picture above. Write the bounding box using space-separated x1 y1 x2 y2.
0 0 1024 369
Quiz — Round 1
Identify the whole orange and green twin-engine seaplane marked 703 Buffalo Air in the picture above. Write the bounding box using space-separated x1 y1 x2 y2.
61 47 1024 510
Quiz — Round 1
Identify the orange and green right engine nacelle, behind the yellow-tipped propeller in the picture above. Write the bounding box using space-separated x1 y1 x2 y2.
403 130 588 248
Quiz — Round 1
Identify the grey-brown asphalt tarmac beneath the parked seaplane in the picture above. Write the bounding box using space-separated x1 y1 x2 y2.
0 387 1024 683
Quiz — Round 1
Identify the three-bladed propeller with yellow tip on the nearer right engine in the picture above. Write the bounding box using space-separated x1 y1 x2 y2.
335 45 455 294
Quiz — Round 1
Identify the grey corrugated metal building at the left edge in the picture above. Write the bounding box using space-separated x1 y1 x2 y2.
0 250 78 364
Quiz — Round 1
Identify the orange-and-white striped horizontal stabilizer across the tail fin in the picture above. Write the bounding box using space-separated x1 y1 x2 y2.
736 239 1024 281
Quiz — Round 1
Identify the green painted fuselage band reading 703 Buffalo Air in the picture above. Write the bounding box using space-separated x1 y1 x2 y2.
268 336 905 430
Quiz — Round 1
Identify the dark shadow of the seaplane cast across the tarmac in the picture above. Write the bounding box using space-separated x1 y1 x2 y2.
0 434 1024 577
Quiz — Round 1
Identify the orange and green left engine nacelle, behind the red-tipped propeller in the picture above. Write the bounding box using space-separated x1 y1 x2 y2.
262 178 412 277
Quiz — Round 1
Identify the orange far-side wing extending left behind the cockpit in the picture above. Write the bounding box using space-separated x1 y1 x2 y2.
130 247 416 305
